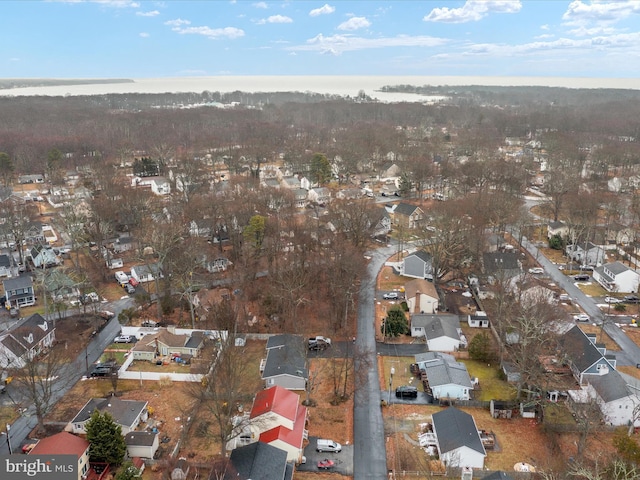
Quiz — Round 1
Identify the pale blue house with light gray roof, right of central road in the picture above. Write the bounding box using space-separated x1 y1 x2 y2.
419 352 473 400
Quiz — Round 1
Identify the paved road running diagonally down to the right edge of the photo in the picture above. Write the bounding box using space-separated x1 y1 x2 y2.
522 237 640 366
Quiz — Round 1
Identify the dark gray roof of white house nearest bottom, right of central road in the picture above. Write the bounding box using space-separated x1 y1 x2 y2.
432 407 486 455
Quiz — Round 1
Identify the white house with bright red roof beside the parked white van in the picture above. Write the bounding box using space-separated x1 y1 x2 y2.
249 386 309 463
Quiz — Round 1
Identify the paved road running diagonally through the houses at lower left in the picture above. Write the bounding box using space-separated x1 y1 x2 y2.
0 298 133 454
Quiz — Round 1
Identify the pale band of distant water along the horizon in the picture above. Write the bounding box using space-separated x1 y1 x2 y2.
0 75 640 102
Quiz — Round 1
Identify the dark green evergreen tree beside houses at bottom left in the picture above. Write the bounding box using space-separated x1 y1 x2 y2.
85 410 127 465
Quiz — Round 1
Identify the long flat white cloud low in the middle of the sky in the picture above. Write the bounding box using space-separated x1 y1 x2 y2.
285 34 447 55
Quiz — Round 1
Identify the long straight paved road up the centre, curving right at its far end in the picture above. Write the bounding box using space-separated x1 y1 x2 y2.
353 247 395 480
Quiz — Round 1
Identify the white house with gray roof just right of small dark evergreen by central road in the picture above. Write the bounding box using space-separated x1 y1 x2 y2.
411 314 466 352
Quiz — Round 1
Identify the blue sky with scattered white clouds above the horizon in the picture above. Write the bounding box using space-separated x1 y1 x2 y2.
0 0 640 78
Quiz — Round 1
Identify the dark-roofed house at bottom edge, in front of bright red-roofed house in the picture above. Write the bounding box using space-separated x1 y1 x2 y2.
222 442 293 480
